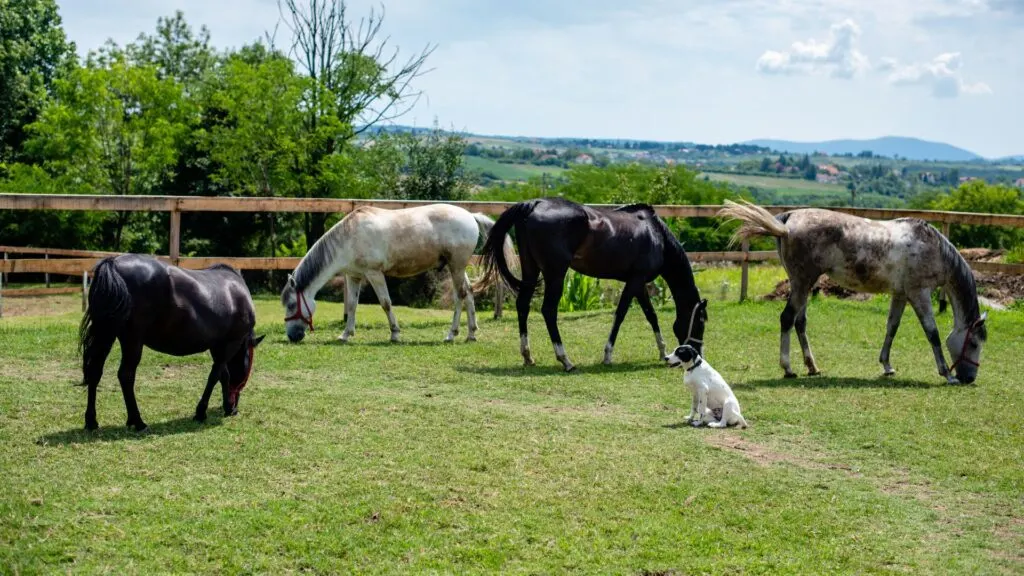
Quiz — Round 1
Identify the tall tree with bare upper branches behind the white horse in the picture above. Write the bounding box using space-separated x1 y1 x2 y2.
278 0 433 244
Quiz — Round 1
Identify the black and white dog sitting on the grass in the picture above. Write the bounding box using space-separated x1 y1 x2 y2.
665 344 746 428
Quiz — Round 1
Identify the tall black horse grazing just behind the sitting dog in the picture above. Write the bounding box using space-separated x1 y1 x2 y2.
482 198 708 372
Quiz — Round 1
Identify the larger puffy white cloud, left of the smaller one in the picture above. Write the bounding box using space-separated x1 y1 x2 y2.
757 18 870 78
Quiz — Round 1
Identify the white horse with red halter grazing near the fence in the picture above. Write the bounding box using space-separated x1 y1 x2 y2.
281 204 516 342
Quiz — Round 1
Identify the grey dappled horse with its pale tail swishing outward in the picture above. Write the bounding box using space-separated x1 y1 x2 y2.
718 200 988 383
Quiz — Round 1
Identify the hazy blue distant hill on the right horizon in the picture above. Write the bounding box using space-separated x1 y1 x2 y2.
743 136 982 162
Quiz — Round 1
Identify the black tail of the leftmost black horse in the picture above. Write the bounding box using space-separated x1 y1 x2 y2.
78 256 132 369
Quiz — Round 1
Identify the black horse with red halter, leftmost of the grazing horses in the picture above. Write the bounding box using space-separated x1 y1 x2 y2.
79 254 263 430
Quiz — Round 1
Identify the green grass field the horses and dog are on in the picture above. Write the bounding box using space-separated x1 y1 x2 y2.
0 266 1024 574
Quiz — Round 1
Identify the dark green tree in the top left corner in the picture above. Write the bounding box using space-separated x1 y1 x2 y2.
0 0 76 165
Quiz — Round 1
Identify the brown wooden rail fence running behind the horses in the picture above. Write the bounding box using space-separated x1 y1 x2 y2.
0 194 1024 316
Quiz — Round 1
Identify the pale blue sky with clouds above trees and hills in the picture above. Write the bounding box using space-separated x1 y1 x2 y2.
58 0 1024 158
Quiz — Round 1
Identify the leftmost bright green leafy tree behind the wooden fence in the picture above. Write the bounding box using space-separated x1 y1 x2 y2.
26 58 193 251
